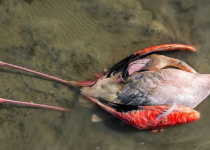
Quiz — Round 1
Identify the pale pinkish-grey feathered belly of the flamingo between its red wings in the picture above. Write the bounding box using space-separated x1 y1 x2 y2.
118 68 210 108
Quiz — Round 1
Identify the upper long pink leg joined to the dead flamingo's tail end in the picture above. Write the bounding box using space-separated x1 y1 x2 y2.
0 61 97 87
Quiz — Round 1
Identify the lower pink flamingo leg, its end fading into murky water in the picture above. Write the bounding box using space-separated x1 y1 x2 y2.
0 98 69 111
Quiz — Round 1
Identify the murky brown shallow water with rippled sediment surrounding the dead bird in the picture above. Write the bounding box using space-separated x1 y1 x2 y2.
0 0 210 150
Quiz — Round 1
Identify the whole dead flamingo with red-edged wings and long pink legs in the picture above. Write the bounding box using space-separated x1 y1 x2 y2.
0 44 201 129
